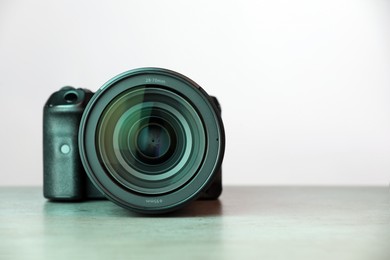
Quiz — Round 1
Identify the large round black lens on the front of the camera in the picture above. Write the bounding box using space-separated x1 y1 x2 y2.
79 68 224 213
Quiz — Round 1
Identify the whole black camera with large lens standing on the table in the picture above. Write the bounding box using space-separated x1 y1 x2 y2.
43 68 225 214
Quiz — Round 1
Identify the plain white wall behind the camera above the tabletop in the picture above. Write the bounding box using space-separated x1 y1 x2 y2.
0 0 390 185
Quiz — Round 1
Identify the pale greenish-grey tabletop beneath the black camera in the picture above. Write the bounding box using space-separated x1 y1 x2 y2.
0 186 390 260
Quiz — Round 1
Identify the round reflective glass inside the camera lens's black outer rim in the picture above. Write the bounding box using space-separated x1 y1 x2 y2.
96 85 206 195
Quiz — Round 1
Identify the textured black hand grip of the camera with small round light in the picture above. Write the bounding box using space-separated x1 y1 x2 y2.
43 107 86 200
